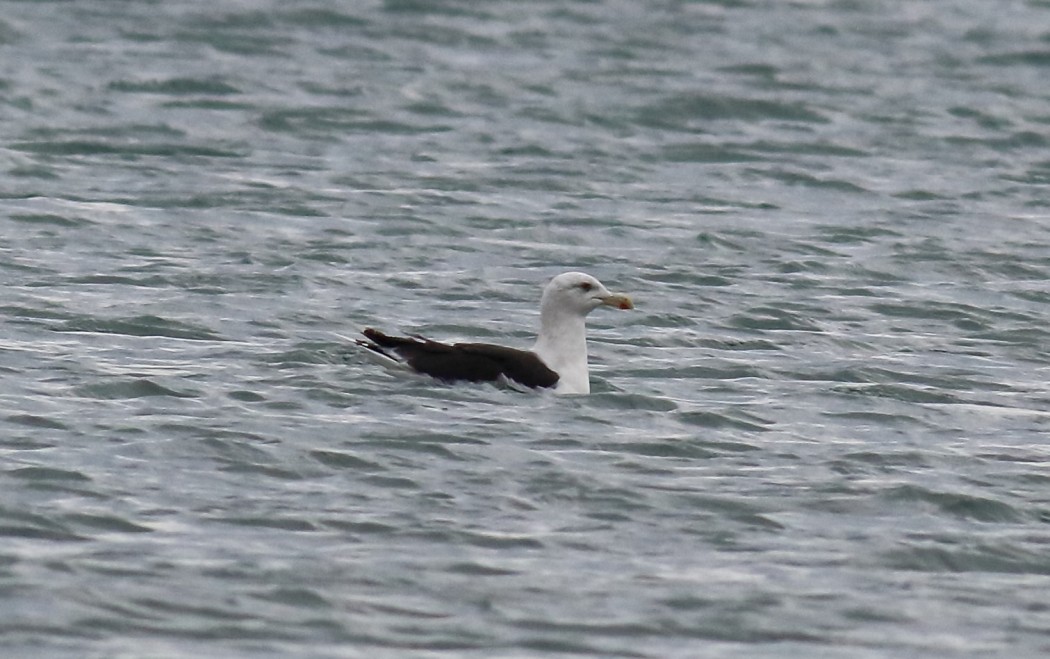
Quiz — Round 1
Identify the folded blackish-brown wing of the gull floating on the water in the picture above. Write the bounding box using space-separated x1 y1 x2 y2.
363 327 558 387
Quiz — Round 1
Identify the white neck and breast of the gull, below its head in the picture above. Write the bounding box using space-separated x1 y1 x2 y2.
532 300 590 394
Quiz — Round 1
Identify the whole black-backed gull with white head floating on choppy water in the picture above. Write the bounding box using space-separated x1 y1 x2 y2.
357 272 634 394
